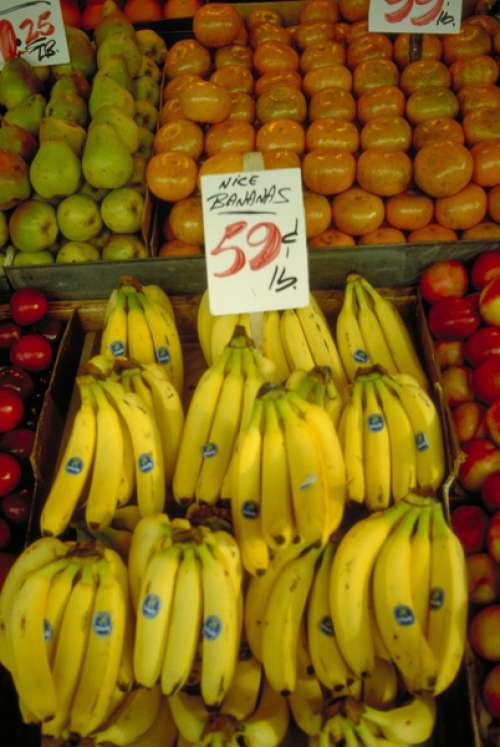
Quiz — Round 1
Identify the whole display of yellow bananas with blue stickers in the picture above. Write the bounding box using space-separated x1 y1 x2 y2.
0 275 467 747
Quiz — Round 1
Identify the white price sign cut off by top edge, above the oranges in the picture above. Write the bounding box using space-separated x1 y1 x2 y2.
368 0 462 34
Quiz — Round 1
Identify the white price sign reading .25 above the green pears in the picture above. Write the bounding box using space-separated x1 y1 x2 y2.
0 0 69 68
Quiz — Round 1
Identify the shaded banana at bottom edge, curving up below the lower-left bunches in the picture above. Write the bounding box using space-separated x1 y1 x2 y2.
94 687 161 747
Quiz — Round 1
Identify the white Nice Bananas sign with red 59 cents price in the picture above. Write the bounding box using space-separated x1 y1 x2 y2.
201 169 309 316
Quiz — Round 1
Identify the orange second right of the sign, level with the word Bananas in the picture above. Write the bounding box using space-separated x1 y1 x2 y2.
332 187 385 236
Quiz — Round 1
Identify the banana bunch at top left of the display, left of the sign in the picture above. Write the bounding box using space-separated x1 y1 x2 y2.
101 277 184 394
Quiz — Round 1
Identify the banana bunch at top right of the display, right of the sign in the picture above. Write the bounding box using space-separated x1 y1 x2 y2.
336 273 428 389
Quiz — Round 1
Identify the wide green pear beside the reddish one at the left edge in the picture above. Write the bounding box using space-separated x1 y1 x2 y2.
30 140 82 200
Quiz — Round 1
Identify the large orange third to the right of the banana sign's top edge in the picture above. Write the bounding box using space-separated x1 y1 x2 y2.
413 141 474 197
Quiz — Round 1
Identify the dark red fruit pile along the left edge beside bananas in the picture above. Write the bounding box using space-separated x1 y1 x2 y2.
0 288 62 588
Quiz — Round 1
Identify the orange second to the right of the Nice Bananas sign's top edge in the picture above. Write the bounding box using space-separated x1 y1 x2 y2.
356 149 413 197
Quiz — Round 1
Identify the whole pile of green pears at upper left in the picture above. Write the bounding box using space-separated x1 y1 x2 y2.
0 0 167 265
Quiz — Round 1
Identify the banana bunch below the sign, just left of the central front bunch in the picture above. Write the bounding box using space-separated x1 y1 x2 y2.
172 327 275 506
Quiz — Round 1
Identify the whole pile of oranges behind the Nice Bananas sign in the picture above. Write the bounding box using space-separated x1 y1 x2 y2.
147 0 500 256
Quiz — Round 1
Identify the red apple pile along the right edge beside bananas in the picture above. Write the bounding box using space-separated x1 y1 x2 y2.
420 250 500 719
